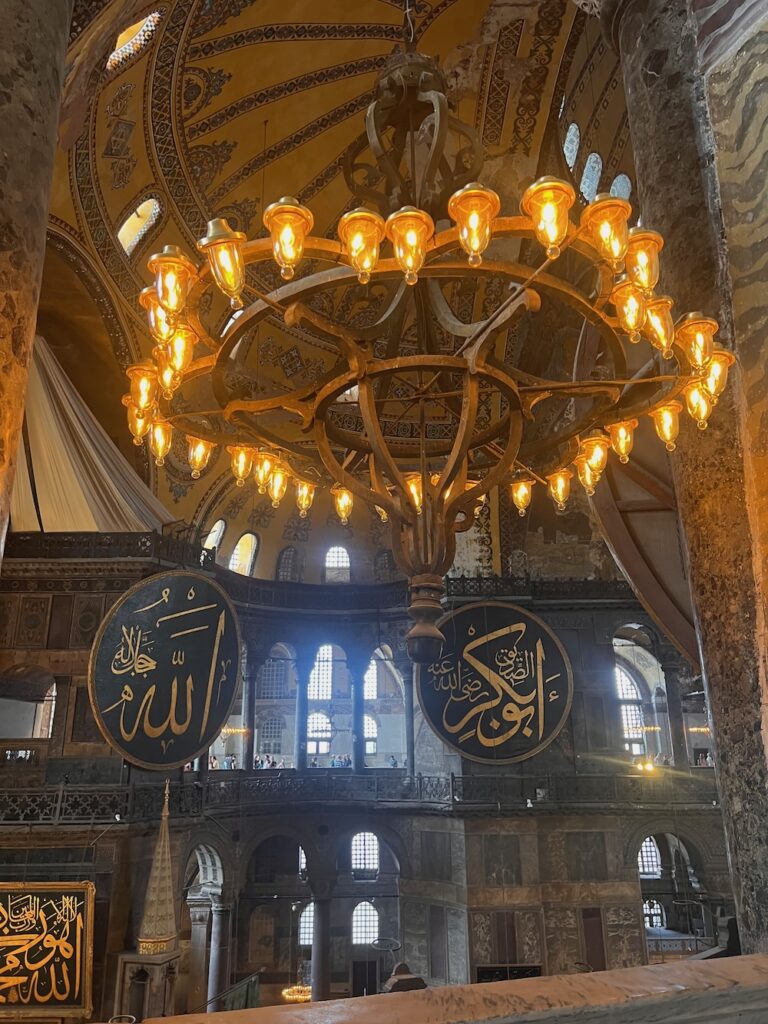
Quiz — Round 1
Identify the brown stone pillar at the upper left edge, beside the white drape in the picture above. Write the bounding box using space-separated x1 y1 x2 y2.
0 0 73 558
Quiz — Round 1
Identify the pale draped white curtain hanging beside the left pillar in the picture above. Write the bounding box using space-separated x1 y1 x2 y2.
10 336 173 532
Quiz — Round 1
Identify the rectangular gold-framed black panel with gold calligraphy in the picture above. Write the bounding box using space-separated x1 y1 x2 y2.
0 882 94 1021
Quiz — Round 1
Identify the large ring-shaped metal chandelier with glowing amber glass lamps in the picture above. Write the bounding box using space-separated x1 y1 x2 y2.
123 47 733 663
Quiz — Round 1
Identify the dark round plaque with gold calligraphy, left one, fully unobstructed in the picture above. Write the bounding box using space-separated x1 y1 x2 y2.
88 572 241 771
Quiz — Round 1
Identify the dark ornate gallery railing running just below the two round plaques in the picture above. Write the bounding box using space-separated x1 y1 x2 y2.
0 769 717 825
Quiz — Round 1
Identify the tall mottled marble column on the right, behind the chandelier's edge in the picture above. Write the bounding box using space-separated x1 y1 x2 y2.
602 0 768 953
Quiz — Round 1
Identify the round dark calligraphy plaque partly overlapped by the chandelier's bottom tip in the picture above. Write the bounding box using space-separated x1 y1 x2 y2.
417 601 573 764
